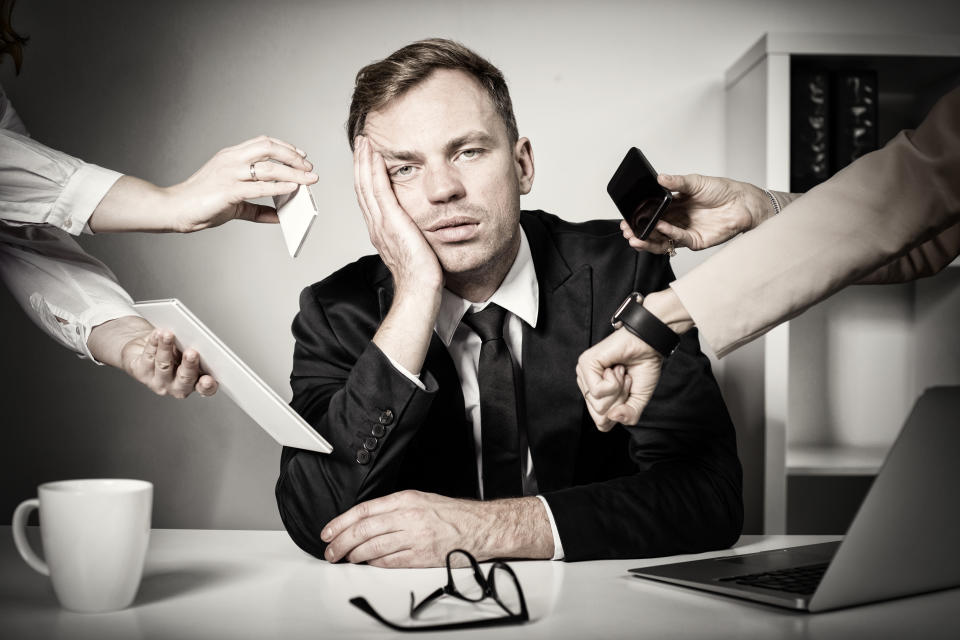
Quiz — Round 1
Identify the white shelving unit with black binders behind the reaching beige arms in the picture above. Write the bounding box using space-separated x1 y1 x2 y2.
724 34 960 534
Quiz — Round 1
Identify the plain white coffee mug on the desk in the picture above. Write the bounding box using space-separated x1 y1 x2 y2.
13 480 153 613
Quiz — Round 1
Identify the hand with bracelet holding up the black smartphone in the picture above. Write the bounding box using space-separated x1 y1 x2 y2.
620 174 774 253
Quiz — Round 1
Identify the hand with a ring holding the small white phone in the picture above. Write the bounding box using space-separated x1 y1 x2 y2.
89 136 318 233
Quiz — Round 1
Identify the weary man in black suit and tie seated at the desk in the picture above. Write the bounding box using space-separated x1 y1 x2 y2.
276 40 743 567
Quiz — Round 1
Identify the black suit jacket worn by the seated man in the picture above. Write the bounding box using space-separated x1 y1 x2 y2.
276 211 743 560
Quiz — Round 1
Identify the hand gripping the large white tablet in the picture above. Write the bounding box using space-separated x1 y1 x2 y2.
87 316 217 398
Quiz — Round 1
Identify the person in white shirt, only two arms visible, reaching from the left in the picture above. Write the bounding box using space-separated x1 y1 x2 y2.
0 80 318 398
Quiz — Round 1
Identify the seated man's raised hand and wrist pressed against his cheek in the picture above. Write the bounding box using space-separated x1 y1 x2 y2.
353 136 443 374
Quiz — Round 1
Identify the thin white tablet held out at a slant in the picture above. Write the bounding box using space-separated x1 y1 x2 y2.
133 298 333 453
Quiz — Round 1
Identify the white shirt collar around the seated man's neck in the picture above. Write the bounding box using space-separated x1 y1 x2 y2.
434 227 540 347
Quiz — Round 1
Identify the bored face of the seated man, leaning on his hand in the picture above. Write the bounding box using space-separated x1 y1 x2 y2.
364 69 533 277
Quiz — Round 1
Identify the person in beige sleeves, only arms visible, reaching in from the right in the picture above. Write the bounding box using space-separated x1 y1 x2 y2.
577 87 960 430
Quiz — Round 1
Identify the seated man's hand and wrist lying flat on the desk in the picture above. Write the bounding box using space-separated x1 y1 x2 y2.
321 491 553 567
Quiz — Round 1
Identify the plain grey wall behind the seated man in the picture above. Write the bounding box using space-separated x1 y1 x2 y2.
0 0 960 531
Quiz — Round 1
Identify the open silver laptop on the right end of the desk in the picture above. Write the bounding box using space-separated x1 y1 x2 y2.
630 387 960 611
